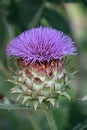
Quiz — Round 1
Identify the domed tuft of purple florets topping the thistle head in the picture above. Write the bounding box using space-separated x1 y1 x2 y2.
6 27 76 63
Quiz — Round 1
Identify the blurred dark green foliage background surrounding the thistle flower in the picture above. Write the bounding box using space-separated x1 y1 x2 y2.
0 0 87 130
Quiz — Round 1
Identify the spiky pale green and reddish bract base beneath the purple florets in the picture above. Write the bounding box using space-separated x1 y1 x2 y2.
9 61 70 110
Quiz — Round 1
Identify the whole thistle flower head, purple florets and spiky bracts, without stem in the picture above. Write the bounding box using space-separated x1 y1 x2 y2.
6 27 76 109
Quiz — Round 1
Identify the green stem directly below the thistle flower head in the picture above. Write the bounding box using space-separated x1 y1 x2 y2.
44 108 58 130
